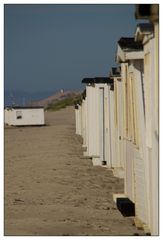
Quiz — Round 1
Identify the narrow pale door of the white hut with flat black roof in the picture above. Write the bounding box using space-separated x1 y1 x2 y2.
99 88 105 161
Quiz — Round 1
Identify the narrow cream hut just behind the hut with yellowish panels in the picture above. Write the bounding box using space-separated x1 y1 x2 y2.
109 67 124 178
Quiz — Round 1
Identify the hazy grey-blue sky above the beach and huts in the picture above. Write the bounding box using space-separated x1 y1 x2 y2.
5 4 138 91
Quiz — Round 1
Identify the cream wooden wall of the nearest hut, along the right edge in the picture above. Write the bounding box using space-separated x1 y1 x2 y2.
144 39 158 234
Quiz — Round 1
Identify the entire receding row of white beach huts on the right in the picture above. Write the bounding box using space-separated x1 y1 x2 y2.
75 4 159 235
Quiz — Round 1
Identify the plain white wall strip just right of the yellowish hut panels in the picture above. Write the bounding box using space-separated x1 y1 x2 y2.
134 60 148 223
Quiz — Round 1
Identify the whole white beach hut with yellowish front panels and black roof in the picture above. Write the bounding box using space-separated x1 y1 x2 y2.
116 38 151 223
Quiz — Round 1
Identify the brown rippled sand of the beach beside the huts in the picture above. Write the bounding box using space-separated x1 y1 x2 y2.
5 107 143 236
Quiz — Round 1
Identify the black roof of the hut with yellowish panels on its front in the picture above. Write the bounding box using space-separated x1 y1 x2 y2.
118 37 143 51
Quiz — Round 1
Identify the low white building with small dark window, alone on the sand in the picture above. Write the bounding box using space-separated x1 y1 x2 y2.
5 107 45 126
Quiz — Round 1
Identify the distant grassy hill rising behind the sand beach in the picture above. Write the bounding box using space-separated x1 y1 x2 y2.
28 90 81 110
